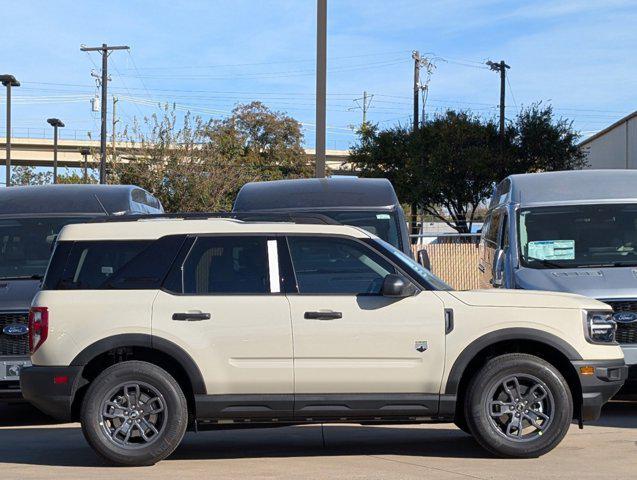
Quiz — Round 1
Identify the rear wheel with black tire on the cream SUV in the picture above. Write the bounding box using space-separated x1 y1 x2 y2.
80 361 188 466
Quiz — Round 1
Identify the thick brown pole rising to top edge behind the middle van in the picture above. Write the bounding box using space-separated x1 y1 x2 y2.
316 0 327 178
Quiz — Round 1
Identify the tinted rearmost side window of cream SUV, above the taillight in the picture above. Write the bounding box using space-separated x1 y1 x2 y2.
43 236 184 290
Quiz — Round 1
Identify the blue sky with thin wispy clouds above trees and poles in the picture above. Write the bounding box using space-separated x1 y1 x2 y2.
0 0 637 154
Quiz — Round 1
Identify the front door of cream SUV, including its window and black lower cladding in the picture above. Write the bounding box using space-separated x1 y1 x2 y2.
288 236 445 418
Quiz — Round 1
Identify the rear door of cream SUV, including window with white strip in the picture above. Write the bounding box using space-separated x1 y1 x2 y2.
152 235 294 418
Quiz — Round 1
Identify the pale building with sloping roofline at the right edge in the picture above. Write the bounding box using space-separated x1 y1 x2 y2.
580 111 637 169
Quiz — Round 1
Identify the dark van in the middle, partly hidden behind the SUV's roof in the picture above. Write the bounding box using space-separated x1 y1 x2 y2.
232 176 412 256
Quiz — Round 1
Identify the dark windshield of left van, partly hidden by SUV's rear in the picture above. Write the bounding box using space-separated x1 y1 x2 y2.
0 217 87 280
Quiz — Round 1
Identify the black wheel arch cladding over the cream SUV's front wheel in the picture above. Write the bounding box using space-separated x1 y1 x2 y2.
444 328 582 418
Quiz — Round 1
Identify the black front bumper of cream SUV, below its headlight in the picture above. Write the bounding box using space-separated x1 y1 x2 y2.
572 360 628 421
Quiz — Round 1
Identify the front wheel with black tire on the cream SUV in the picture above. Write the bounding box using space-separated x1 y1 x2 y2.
464 353 573 458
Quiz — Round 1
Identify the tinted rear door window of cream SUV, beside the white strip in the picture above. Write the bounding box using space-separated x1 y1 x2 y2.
183 236 270 295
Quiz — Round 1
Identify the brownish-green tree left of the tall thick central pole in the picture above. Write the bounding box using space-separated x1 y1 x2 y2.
109 102 311 212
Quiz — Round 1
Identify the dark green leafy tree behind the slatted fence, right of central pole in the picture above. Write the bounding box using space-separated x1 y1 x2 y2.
351 104 585 233
